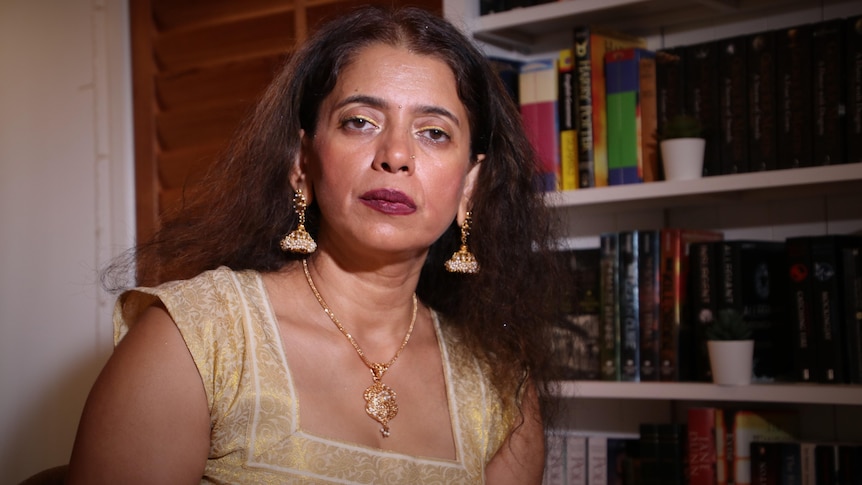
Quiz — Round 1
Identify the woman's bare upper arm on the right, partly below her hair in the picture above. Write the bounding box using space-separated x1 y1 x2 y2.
485 388 545 485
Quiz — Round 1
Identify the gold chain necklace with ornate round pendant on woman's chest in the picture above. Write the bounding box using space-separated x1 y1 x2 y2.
302 259 419 438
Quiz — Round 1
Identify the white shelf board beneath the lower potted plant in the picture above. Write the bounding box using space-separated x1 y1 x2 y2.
558 381 862 406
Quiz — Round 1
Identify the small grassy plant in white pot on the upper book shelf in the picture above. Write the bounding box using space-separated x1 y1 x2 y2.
658 114 706 180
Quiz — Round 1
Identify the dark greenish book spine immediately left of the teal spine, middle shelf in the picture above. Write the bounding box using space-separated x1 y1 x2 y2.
599 233 620 381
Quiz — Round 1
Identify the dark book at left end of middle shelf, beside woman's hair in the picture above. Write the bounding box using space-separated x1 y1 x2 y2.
550 248 601 380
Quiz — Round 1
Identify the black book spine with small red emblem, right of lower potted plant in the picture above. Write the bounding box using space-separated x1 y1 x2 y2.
784 237 817 382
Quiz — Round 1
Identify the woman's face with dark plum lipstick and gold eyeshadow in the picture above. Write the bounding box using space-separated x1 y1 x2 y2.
300 44 481 262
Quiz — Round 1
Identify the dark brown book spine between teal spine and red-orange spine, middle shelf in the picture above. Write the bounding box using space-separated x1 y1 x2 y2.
638 231 661 381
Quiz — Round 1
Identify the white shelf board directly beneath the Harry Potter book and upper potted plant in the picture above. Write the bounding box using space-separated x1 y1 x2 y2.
545 163 862 211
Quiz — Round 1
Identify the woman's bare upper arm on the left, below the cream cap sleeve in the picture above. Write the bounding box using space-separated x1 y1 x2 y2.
68 307 210 484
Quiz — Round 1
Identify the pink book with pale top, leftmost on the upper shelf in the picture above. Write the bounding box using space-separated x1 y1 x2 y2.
518 59 560 192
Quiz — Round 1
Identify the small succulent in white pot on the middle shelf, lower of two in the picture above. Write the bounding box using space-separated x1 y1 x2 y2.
706 309 754 386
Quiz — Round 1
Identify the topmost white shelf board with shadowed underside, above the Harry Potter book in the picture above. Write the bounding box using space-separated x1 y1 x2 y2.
472 0 846 53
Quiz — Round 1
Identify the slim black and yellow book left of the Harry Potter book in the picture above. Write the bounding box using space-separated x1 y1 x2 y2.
557 49 578 190
